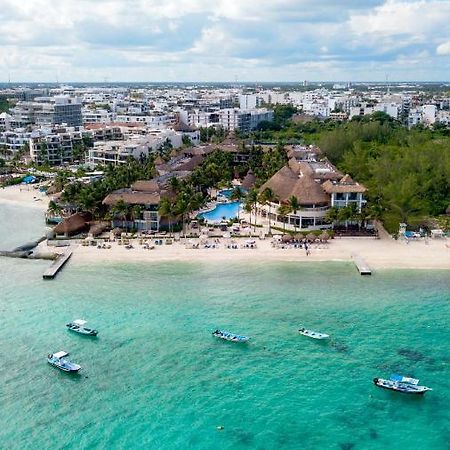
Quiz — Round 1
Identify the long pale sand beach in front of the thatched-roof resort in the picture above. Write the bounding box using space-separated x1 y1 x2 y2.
52 238 450 270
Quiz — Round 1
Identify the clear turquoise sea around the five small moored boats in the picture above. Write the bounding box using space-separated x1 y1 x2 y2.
0 205 450 450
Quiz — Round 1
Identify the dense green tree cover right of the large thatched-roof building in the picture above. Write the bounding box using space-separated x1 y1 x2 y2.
247 107 450 232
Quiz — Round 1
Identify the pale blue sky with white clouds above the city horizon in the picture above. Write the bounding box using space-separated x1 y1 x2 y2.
0 0 450 82
